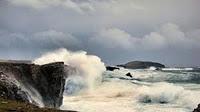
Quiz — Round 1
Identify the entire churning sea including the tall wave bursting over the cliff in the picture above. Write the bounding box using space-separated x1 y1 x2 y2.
34 49 200 112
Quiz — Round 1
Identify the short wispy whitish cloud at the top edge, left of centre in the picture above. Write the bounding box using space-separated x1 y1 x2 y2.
8 0 94 14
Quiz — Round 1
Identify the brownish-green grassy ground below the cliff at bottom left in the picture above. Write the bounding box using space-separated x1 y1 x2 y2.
0 98 75 112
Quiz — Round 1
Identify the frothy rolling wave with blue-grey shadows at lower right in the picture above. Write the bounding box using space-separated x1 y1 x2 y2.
138 82 200 109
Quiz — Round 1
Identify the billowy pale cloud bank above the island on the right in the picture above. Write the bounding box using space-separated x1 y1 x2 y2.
90 23 200 51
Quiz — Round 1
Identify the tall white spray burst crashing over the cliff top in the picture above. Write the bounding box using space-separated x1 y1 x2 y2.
33 48 106 91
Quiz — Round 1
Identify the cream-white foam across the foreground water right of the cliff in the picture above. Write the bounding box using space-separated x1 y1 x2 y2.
61 80 200 112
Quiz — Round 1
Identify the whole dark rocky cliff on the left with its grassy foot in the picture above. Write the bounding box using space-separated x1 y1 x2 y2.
0 61 76 112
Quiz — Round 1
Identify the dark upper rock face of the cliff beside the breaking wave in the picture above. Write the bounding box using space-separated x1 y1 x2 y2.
0 62 65 108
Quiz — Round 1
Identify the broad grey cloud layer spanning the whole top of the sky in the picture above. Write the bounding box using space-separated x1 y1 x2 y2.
0 0 200 35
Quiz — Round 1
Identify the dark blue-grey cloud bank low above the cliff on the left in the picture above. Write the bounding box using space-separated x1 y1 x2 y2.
0 30 81 59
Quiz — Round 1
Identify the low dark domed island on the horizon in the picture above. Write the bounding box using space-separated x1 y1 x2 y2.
117 61 165 69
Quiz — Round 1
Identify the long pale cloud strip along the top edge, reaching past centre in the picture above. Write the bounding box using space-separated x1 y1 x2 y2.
8 0 144 15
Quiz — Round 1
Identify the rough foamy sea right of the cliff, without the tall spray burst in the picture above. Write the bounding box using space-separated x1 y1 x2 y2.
61 68 200 112
